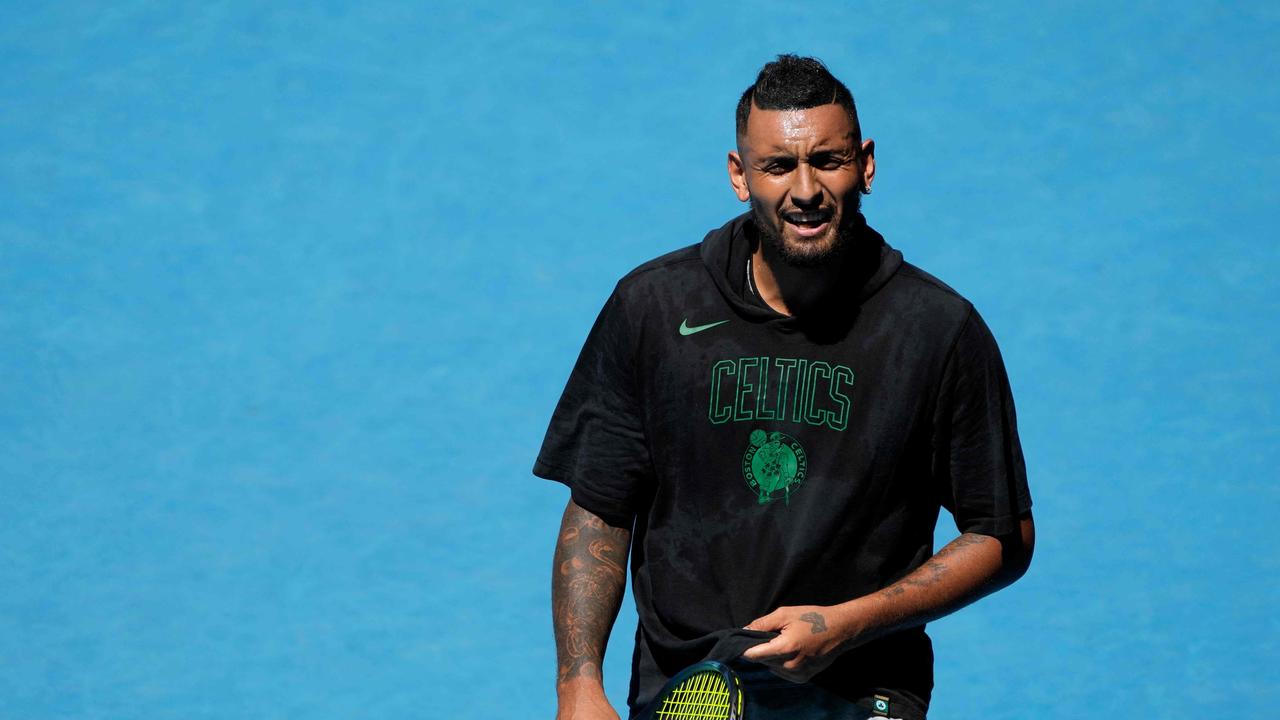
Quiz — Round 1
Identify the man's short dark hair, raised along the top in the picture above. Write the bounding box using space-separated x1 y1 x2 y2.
737 54 863 142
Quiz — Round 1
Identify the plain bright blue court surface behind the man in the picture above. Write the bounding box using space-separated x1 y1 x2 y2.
0 0 1280 720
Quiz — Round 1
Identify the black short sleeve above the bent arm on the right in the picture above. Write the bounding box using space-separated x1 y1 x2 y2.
933 304 1032 537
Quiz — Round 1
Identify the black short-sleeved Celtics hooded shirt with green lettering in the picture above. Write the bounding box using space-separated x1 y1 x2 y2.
534 215 1030 717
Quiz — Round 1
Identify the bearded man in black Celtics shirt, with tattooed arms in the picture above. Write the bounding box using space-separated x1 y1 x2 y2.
534 55 1034 720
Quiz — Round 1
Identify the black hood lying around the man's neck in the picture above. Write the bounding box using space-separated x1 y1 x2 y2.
699 211 902 331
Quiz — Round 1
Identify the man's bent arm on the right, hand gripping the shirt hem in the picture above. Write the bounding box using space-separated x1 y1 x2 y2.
742 512 1036 683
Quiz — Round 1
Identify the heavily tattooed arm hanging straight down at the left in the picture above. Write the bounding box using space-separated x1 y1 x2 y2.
552 500 631 720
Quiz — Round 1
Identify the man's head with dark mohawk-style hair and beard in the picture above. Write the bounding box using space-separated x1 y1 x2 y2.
728 55 876 266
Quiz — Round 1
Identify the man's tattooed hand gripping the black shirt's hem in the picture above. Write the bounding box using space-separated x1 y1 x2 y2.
742 605 849 683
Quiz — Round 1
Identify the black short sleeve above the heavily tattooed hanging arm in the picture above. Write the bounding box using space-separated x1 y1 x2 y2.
534 291 652 528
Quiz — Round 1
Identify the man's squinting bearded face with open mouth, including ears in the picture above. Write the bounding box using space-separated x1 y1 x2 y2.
728 104 876 266
